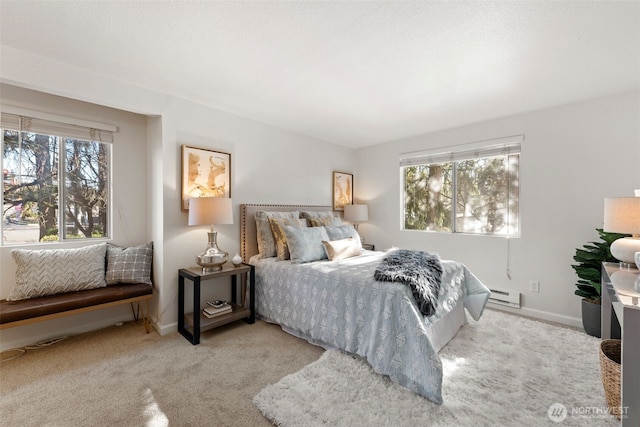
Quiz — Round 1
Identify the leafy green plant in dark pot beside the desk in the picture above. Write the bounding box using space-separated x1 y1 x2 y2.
571 228 629 338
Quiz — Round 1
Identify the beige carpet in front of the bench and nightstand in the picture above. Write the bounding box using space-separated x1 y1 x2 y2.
0 321 324 427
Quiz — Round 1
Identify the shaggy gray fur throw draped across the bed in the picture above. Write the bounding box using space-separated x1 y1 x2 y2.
373 249 442 316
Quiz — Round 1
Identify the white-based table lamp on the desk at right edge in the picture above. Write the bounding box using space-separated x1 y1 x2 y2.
603 197 640 265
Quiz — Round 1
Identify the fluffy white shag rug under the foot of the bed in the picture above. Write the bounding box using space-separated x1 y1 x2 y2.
253 310 619 427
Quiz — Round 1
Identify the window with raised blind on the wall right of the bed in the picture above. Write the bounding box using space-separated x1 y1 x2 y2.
400 136 523 237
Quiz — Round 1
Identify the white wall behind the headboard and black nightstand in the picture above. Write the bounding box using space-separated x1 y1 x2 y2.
158 99 354 334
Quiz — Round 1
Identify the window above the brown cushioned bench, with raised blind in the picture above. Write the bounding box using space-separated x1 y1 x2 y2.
0 112 115 245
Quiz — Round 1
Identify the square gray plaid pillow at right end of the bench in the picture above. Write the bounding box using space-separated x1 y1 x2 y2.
106 242 153 285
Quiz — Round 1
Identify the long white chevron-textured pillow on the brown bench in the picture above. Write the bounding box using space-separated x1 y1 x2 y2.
7 243 107 301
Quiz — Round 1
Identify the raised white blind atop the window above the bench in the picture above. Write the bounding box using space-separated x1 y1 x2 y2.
0 112 115 143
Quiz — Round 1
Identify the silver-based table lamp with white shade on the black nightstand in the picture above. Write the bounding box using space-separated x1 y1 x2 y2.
189 197 233 273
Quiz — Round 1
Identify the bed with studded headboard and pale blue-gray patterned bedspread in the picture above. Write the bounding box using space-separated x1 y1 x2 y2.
240 204 490 403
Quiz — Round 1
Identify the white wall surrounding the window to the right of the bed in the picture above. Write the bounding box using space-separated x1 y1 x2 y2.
355 92 640 326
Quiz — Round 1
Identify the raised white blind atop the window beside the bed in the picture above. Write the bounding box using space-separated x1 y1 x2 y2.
400 135 524 167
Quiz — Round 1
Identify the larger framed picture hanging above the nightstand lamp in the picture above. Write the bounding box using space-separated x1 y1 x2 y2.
182 145 231 211
